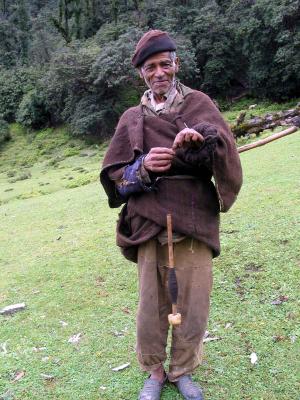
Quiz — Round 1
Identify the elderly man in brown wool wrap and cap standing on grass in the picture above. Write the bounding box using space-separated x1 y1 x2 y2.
100 30 242 400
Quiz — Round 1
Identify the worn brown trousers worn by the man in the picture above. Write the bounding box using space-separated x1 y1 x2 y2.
136 238 212 381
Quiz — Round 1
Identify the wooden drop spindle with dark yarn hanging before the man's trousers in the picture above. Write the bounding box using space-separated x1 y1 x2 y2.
167 214 181 325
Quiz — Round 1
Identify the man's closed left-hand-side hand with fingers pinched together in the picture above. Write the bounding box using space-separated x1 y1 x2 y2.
144 147 175 172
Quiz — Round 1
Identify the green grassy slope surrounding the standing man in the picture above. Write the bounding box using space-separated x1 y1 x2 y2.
0 116 300 400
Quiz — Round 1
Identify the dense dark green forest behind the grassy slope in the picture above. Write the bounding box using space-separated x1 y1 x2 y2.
0 0 300 142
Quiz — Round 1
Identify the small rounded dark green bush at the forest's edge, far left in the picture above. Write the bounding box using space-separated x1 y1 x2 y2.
17 89 50 129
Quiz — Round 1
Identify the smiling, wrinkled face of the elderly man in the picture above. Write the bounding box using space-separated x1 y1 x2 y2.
140 51 178 97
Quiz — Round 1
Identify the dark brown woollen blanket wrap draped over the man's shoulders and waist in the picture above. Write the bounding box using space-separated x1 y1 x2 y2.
100 91 242 262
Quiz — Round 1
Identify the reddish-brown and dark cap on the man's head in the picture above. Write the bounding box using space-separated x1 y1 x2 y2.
132 30 176 68
